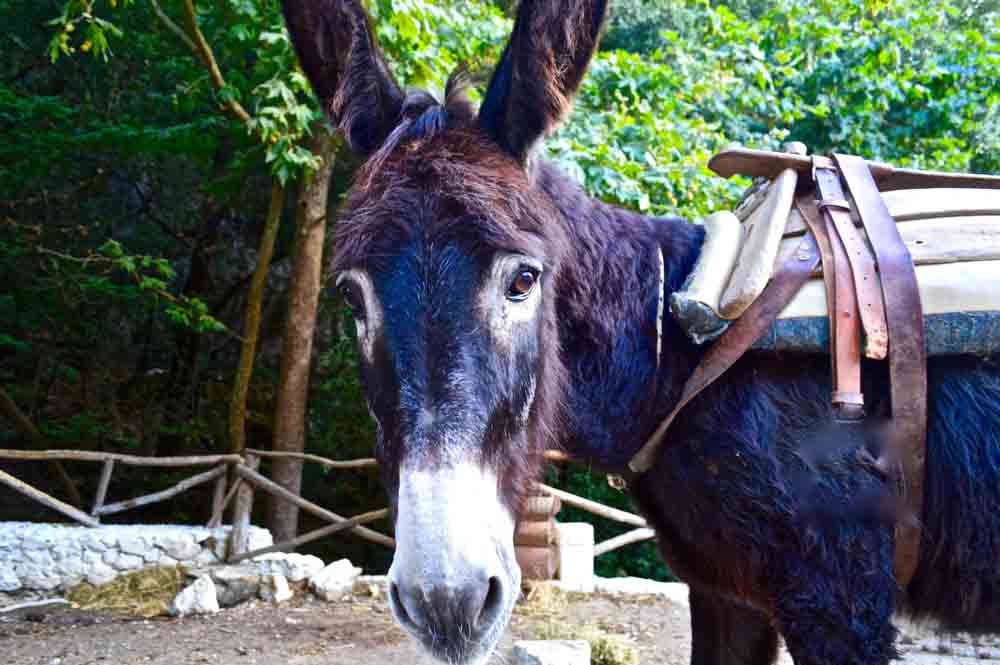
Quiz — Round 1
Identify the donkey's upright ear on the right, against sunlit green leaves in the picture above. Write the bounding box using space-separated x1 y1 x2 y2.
479 0 608 163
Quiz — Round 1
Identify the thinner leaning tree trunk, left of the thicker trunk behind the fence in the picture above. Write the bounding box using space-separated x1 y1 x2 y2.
229 180 285 453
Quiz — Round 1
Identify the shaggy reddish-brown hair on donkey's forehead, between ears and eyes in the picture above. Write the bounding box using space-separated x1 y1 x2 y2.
333 74 567 278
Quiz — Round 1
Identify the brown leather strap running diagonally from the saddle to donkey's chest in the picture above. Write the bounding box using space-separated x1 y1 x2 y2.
628 205 820 475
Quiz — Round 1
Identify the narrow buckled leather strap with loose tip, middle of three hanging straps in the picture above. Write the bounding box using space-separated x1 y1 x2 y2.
813 164 895 360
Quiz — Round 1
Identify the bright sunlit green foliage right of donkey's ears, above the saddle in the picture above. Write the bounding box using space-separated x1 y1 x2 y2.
549 0 1000 223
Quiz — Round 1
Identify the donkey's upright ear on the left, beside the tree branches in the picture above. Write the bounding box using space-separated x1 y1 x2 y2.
281 0 404 156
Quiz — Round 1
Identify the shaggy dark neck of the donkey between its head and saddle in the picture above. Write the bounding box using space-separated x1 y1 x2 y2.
537 164 704 470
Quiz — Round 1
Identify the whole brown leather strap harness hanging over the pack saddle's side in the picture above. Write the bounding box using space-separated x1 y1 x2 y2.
626 151 940 588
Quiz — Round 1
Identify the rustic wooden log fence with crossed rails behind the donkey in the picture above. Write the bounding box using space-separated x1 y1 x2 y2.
0 448 654 563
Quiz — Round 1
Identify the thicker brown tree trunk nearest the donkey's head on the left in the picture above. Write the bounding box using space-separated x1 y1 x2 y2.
267 129 337 542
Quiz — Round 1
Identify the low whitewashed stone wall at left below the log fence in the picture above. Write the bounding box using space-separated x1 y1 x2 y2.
0 522 273 595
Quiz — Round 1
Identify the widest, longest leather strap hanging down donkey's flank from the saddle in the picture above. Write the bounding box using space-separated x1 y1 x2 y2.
834 154 927 588
